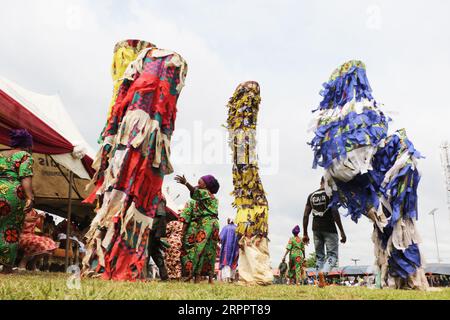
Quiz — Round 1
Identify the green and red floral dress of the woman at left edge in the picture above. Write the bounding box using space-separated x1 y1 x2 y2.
0 151 33 266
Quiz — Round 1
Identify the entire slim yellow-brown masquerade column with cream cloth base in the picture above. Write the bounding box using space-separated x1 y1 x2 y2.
227 81 273 285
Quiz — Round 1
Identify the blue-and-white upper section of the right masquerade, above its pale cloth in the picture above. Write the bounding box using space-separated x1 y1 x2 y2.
310 61 389 169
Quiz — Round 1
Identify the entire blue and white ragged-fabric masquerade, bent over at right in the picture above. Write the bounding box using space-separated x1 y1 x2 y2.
311 61 428 288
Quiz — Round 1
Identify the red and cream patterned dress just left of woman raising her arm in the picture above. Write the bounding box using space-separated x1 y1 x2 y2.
165 220 183 280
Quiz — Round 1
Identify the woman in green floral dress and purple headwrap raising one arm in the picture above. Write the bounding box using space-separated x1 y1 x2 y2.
175 175 219 284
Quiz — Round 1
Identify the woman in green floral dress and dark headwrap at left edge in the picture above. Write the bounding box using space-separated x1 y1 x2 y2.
0 129 34 273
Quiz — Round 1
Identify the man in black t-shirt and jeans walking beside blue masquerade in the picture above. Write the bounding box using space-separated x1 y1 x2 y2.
303 177 347 284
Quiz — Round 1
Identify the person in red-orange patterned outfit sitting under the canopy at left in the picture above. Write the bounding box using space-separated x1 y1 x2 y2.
19 210 58 271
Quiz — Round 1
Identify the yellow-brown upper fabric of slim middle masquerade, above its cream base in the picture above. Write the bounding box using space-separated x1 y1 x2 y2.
227 81 268 237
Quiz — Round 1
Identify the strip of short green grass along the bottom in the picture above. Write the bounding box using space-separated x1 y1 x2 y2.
0 273 450 300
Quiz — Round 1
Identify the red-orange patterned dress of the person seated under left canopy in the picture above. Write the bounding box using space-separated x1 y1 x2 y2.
19 210 58 256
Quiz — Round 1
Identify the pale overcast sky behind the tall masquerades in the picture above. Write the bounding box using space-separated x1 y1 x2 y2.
0 0 450 266
